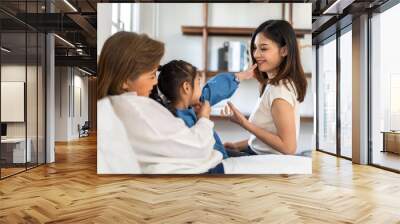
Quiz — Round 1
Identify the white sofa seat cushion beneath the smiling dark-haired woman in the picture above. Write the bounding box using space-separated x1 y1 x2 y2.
222 155 312 174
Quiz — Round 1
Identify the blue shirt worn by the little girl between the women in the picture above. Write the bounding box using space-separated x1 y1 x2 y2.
176 72 239 159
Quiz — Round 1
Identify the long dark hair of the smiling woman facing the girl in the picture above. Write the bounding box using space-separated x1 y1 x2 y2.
250 20 307 102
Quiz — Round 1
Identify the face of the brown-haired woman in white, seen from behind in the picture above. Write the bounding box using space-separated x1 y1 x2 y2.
122 64 158 97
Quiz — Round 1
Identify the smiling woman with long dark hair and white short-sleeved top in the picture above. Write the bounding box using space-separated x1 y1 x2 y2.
223 20 307 155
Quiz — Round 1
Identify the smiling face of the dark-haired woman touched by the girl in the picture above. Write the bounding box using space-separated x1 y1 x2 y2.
253 33 287 73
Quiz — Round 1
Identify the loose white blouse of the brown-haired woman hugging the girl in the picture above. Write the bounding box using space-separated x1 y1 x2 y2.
98 93 222 174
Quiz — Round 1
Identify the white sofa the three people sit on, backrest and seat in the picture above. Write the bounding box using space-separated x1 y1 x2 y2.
97 102 312 174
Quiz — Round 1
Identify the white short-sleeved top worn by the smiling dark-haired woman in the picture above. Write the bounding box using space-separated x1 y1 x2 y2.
248 80 300 154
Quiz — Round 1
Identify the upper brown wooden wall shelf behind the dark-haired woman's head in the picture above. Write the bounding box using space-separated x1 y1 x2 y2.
182 26 311 38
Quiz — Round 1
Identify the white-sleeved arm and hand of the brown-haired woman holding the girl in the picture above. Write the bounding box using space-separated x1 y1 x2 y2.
112 95 215 160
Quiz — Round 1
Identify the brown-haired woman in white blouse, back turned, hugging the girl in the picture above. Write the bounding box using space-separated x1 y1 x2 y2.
98 32 223 174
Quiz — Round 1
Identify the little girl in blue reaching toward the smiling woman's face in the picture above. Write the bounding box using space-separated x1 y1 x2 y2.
153 60 255 159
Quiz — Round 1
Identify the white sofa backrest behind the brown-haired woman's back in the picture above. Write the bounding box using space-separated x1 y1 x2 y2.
97 98 141 174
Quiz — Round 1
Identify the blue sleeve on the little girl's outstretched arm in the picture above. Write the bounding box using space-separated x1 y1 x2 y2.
200 72 239 106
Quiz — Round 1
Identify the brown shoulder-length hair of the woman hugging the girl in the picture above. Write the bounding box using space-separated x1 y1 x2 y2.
97 31 164 99
